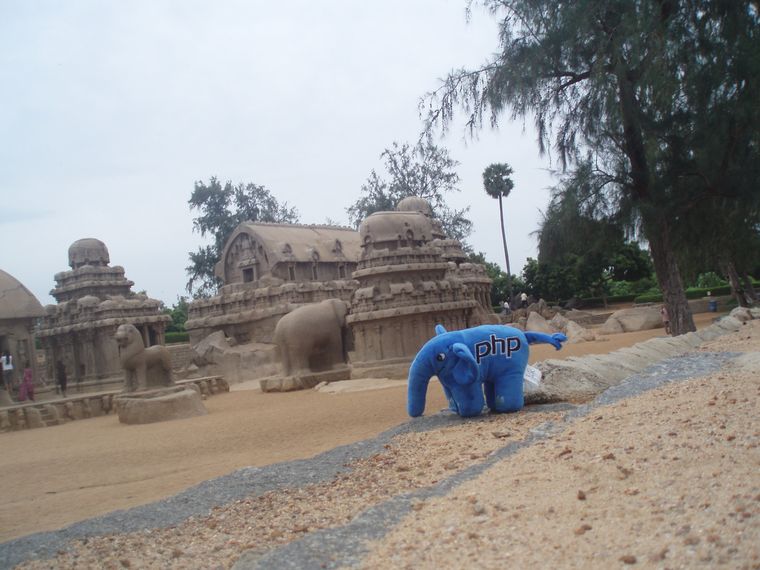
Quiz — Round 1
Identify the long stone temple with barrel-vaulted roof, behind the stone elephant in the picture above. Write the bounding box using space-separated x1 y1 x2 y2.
185 222 360 344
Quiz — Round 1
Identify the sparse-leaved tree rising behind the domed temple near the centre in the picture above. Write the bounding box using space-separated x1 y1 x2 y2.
346 139 472 241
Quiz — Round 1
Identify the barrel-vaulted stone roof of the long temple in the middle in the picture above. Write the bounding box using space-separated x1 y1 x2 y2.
222 222 361 265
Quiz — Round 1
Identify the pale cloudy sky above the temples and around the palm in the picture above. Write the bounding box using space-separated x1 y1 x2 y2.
0 0 553 305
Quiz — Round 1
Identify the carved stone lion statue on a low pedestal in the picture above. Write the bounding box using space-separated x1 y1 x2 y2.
114 325 174 392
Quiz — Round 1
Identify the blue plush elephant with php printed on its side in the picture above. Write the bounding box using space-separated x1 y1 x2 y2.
407 325 567 417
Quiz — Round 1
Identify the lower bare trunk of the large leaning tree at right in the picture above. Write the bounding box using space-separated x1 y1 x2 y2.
647 220 697 336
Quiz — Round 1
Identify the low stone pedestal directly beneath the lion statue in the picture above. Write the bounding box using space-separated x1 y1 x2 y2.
114 386 208 424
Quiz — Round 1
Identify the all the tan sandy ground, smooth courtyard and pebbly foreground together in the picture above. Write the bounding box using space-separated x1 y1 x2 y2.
0 314 760 567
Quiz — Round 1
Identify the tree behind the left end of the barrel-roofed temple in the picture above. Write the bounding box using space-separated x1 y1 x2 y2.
186 177 298 298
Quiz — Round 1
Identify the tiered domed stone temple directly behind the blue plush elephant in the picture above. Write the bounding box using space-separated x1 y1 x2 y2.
347 198 495 376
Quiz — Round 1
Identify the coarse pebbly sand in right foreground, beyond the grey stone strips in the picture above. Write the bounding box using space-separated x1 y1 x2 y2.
363 321 760 569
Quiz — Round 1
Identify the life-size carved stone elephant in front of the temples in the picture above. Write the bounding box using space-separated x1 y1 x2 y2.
274 299 349 376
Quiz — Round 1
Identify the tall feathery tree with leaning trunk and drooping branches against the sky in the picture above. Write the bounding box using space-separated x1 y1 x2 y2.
423 0 760 334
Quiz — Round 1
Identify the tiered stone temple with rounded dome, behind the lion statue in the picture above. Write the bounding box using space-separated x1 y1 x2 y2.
37 238 171 383
